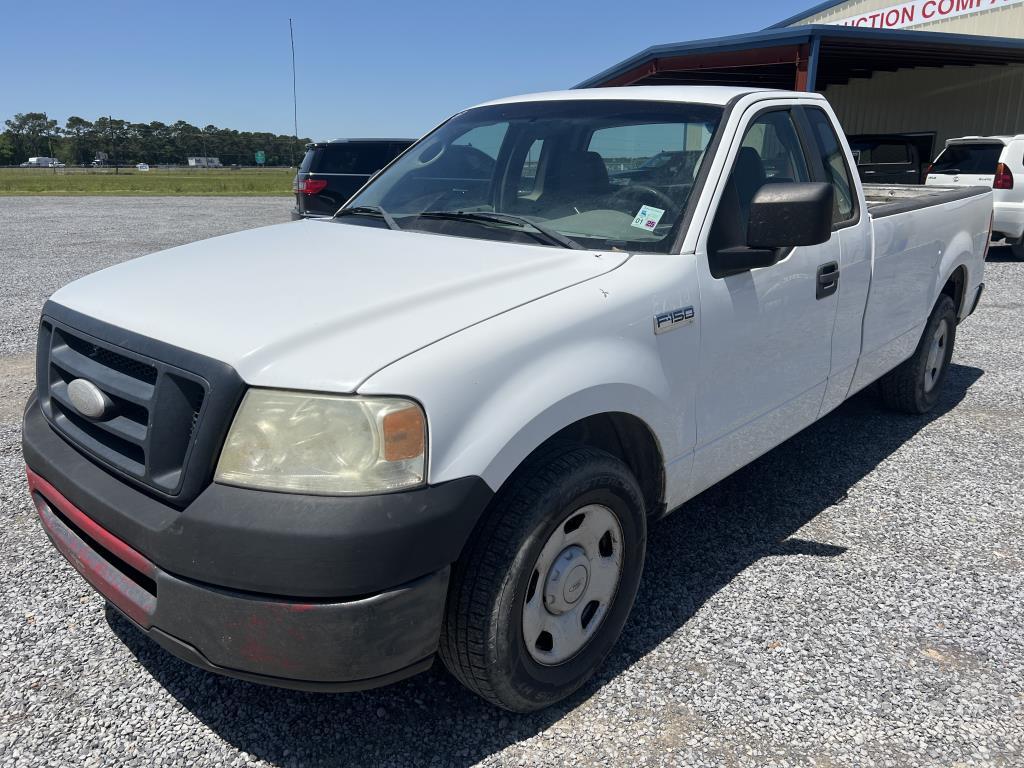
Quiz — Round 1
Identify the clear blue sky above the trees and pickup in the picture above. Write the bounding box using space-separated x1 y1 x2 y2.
0 0 814 139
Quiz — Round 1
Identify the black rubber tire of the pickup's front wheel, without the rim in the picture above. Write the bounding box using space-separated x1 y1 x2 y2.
440 444 647 712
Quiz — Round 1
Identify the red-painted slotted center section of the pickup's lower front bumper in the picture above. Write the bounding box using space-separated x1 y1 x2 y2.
26 467 157 629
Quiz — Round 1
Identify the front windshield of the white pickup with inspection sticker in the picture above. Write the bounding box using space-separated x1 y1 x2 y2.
337 99 722 253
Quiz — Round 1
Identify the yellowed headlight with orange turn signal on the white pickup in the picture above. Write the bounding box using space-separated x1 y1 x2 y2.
215 389 427 495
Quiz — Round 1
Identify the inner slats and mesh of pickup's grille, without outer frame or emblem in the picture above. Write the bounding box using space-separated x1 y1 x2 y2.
39 318 208 495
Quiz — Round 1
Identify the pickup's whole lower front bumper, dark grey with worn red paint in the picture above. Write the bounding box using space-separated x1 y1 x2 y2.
26 456 449 691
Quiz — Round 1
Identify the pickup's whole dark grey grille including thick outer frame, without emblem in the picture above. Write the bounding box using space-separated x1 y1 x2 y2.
36 301 245 508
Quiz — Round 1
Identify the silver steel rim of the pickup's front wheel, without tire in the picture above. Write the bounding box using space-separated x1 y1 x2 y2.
522 504 623 667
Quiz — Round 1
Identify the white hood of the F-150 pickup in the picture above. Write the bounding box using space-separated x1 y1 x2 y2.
52 221 628 392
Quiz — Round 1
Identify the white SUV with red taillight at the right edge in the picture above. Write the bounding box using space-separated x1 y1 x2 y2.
926 134 1024 259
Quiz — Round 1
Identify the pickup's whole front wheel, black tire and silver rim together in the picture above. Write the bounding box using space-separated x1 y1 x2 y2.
440 445 646 712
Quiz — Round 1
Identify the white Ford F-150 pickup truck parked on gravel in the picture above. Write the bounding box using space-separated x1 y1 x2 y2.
23 87 992 711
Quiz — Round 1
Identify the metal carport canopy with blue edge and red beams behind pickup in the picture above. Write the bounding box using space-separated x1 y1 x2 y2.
575 25 1024 91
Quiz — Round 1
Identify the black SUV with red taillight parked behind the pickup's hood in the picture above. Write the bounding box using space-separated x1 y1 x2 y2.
292 138 413 219
